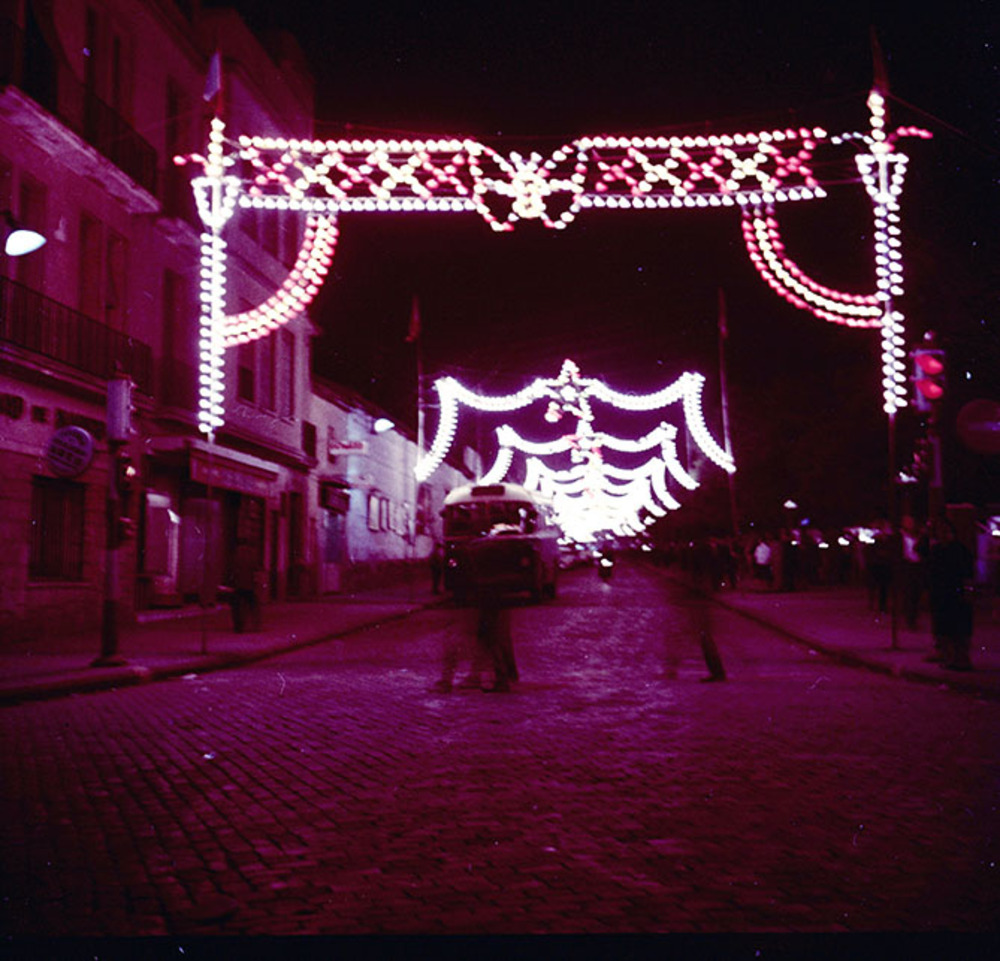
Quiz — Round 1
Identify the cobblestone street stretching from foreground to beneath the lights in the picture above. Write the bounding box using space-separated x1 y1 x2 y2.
0 565 1000 936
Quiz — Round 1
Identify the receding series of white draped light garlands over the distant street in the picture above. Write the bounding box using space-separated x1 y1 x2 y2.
417 360 736 541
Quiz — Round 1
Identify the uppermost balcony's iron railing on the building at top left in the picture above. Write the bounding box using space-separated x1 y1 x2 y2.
0 14 157 196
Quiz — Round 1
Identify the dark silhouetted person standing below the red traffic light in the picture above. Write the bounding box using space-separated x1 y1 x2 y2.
927 518 974 671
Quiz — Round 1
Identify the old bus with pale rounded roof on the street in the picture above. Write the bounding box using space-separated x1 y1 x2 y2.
441 483 559 602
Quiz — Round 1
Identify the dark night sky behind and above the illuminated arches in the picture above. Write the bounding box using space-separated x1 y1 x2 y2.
215 0 1000 525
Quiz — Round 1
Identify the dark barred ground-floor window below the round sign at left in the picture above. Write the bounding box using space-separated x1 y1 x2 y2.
28 477 84 581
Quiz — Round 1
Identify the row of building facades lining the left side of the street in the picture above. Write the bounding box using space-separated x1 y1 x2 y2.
0 0 476 638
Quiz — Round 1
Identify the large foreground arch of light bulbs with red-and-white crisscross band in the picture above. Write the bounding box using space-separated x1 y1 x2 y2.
175 90 930 436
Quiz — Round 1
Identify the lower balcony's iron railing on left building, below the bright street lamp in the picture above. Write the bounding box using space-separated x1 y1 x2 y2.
0 277 153 394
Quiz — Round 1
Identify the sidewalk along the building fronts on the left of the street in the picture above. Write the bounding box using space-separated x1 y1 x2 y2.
0 583 444 705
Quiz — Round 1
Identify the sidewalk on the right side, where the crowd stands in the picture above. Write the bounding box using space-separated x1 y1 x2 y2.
713 582 1000 700
